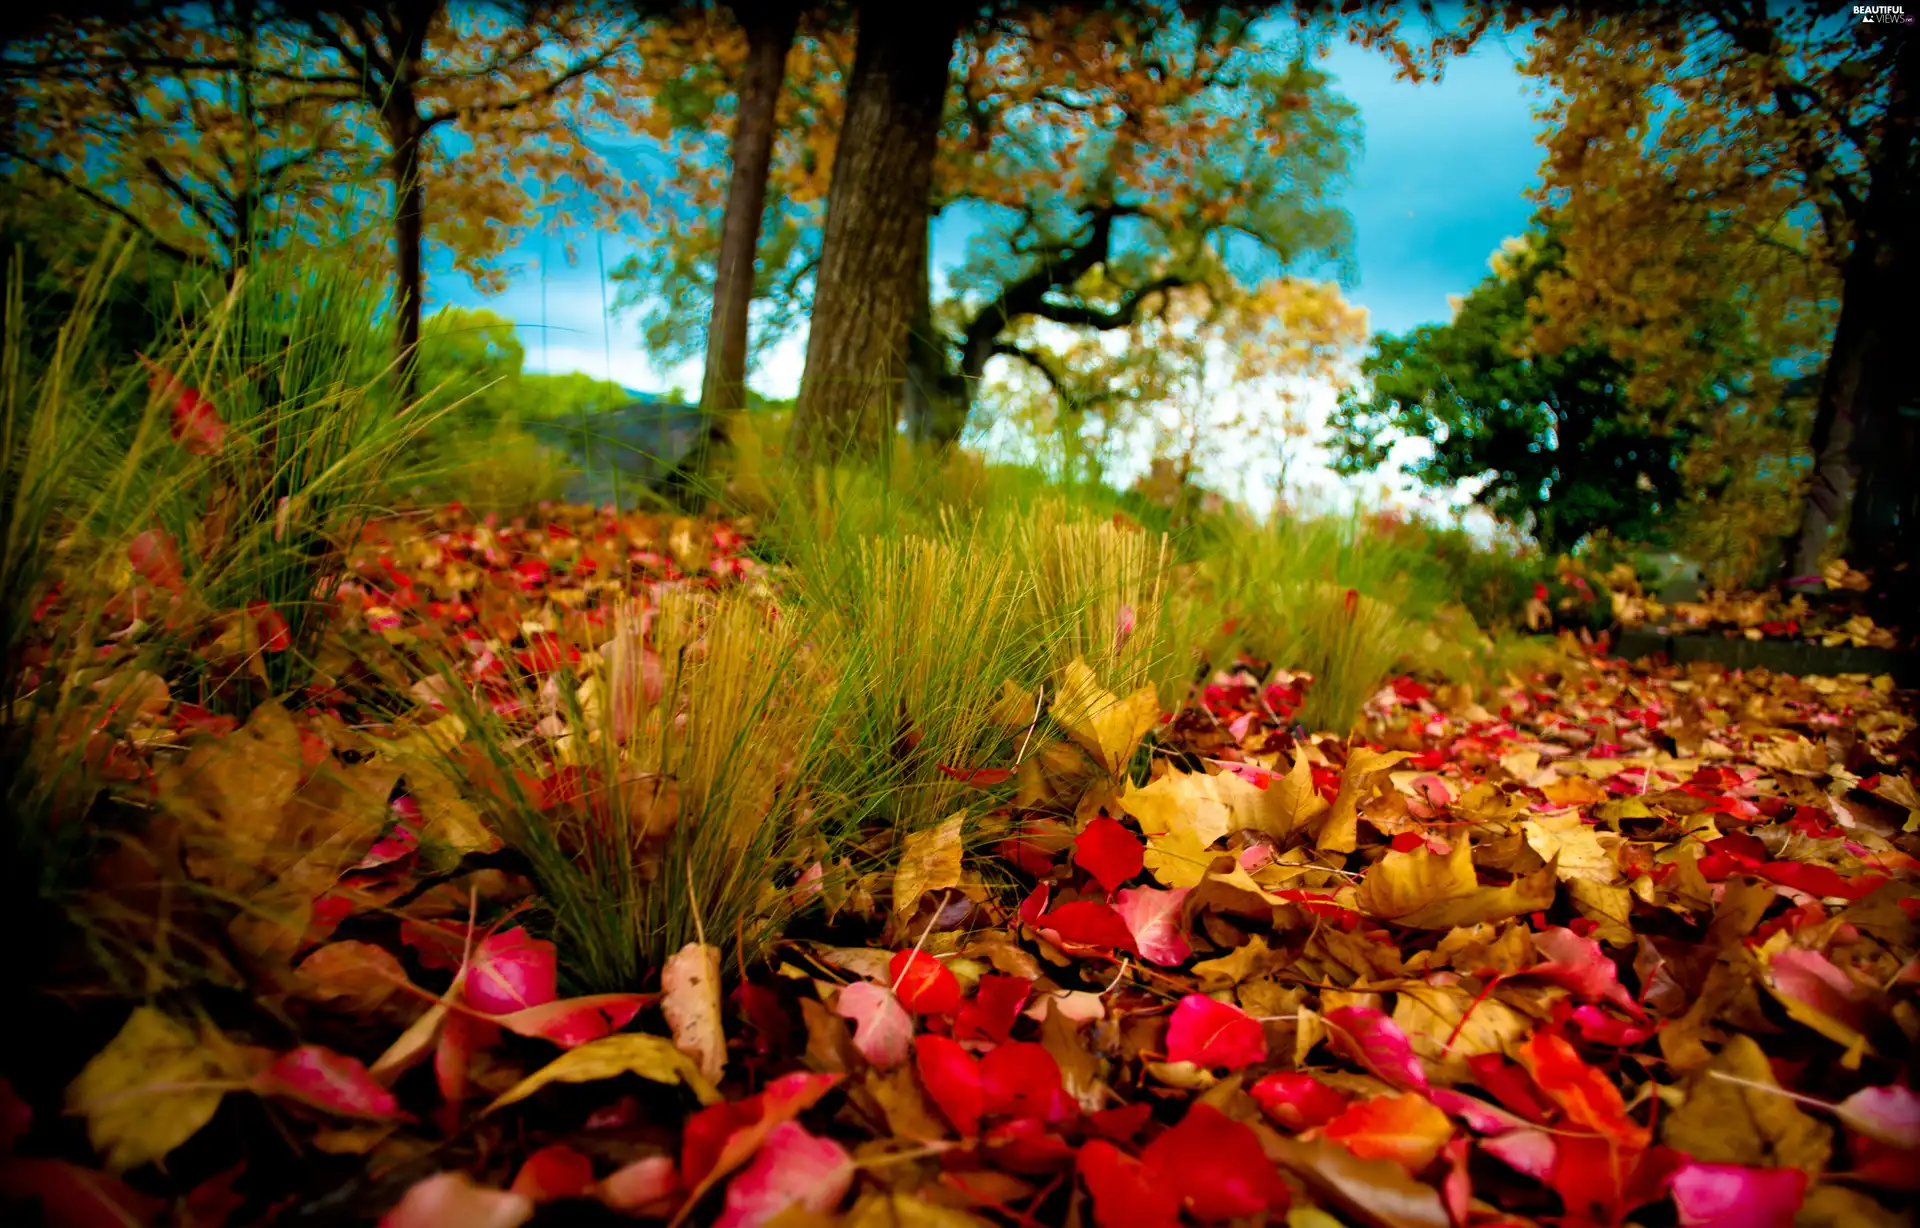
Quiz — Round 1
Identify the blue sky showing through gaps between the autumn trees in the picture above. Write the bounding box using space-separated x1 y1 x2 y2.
428 38 1540 506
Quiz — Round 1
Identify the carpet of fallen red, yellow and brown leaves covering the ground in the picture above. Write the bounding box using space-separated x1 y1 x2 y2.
0 502 1920 1228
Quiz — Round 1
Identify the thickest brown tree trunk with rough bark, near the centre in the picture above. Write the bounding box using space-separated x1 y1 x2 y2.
793 0 960 461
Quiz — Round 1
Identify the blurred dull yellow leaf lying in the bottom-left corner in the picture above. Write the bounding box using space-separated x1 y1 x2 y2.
67 1005 227 1172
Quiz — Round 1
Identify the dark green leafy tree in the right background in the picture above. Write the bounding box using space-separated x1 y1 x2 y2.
1331 234 1693 551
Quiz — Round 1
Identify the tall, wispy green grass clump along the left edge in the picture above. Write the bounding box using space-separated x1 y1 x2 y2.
0 230 441 988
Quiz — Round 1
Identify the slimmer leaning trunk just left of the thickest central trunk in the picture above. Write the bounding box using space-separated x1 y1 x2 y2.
701 0 799 436
